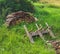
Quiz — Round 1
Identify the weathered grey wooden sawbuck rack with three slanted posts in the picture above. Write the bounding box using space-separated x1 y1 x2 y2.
24 23 55 43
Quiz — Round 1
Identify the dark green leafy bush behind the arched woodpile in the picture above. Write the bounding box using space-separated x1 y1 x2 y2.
0 0 34 25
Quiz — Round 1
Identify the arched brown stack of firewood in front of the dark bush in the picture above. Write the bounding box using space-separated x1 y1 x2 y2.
5 11 37 26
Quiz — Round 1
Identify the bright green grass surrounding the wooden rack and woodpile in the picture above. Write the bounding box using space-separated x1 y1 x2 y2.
0 4 60 54
